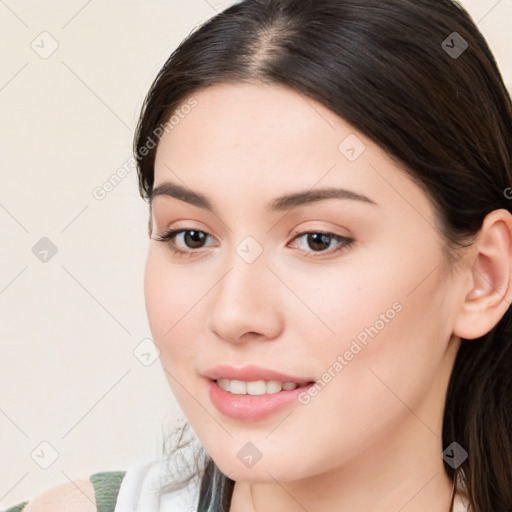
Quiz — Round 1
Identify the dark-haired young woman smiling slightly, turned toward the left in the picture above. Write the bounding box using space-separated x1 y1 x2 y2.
9 0 512 512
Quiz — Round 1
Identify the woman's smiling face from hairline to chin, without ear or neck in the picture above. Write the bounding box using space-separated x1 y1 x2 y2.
145 84 460 482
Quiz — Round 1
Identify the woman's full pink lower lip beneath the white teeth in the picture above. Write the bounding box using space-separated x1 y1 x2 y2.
208 379 314 421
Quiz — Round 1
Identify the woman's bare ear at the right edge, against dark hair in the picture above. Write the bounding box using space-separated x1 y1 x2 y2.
453 209 512 339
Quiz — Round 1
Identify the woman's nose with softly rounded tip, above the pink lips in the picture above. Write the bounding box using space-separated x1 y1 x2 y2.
208 254 283 344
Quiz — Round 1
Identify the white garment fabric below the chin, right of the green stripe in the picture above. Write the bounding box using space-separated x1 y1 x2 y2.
114 459 201 512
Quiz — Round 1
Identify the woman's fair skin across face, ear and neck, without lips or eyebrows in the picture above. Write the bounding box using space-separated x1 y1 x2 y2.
144 84 512 512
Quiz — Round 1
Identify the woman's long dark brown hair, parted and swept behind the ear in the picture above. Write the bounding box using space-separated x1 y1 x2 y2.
134 0 512 512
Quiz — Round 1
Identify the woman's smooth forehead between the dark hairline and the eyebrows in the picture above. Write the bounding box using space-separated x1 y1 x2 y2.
155 83 436 228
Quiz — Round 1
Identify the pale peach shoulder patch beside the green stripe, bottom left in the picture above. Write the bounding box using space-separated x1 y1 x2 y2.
23 479 97 512
